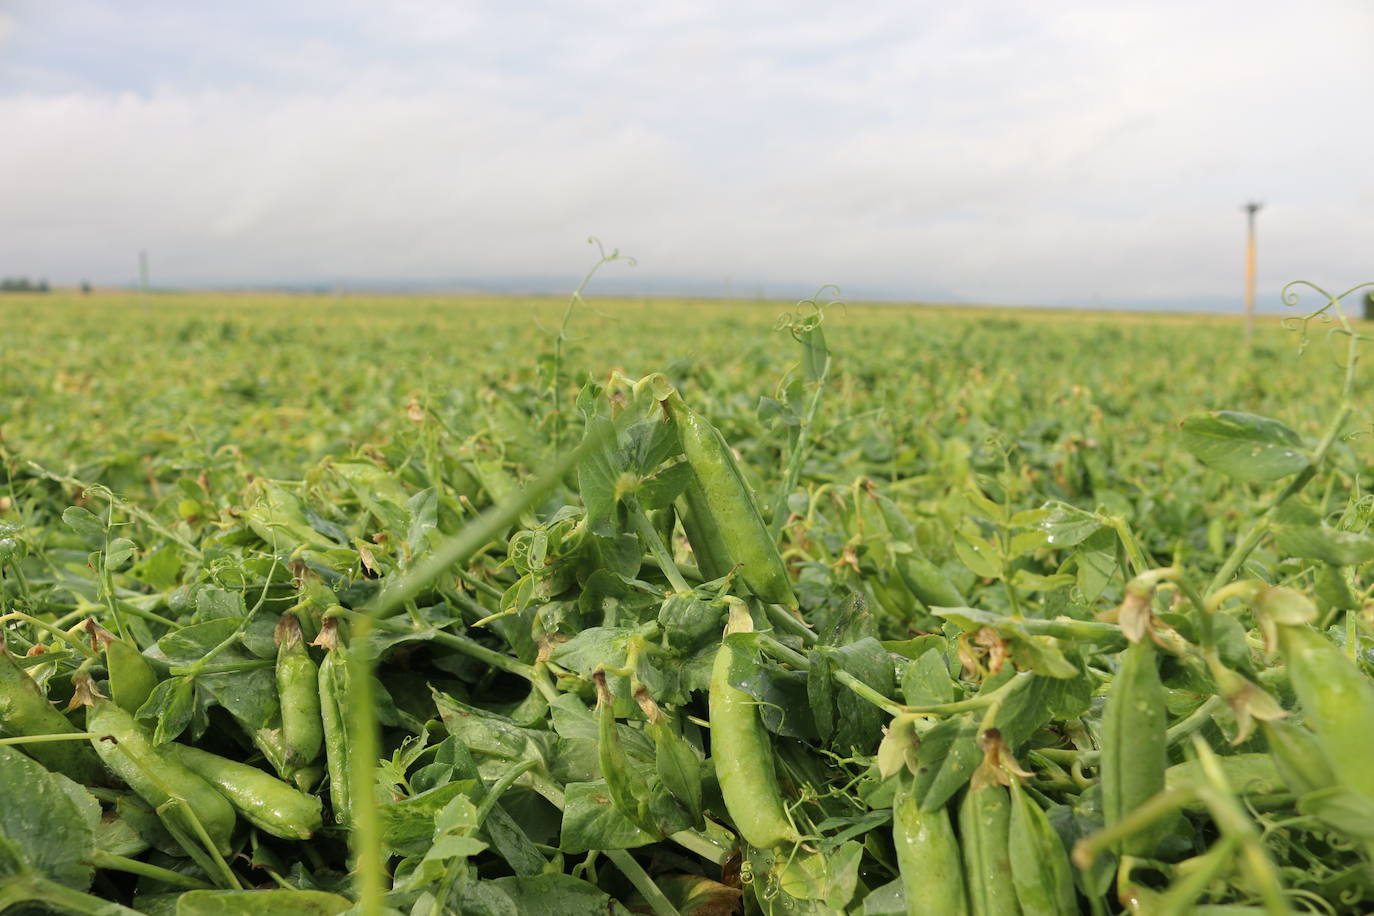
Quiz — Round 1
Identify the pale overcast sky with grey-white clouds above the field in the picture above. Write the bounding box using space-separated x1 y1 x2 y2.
0 0 1374 308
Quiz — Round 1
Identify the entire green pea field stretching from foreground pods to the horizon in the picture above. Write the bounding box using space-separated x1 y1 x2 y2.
0 282 1374 916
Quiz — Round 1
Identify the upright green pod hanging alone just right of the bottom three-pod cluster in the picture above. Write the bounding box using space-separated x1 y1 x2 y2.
1101 639 1169 856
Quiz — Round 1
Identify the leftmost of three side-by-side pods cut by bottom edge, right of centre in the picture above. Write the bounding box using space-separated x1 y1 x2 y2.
892 776 969 916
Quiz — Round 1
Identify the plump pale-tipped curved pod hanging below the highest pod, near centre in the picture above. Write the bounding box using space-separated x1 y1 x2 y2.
709 599 801 849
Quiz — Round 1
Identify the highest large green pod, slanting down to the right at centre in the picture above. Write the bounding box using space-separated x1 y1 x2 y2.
664 391 797 608
